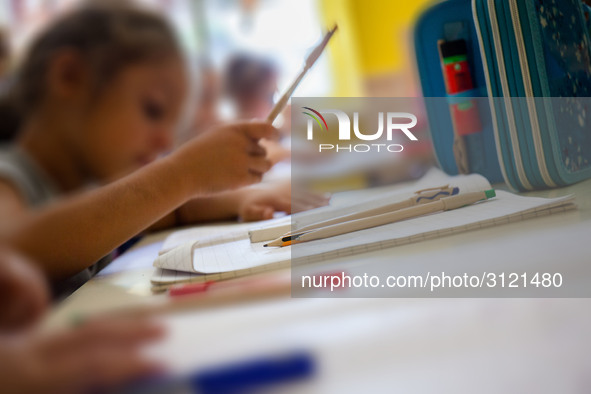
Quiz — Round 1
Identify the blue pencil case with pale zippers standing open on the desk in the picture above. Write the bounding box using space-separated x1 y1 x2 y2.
415 0 591 190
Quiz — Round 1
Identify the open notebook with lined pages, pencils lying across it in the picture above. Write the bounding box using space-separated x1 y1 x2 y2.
152 170 576 286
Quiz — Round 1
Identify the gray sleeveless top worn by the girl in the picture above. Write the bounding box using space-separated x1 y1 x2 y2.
0 146 112 298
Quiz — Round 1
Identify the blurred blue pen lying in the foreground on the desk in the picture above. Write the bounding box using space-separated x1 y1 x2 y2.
121 352 315 394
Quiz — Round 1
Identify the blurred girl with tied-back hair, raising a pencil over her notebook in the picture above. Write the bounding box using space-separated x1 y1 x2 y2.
0 2 310 292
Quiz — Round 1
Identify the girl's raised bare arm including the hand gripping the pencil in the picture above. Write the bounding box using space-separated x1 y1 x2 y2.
3 123 275 279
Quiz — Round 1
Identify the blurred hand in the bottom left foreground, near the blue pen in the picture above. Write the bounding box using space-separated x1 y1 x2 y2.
0 318 164 394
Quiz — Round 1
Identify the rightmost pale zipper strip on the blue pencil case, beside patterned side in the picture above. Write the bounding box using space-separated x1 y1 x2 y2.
509 0 556 187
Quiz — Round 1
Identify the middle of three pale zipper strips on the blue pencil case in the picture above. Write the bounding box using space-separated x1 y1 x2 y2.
487 0 532 189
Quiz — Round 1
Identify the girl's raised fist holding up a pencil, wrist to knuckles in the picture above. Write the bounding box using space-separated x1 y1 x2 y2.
172 122 277 195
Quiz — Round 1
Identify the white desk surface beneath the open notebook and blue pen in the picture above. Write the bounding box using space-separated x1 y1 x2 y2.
42 180 591 393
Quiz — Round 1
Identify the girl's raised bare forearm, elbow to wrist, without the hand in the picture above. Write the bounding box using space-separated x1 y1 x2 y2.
6 155 192 279
